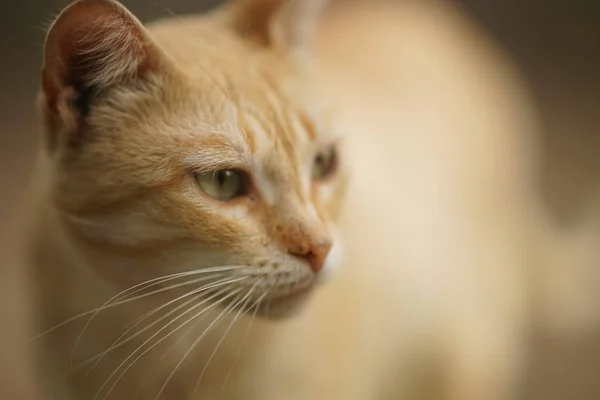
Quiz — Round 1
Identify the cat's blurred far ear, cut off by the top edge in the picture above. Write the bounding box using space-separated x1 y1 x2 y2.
229 0 328 53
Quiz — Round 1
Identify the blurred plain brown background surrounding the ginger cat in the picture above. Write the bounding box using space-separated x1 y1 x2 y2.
0 0 600 400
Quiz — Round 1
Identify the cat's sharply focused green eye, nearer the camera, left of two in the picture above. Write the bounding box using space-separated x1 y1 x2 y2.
196 169 246 201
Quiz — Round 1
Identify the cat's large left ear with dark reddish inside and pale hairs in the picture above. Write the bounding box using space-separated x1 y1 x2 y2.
42 0 164 123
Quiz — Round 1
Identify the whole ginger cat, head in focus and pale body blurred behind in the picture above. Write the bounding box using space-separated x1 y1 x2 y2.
28 0 584 400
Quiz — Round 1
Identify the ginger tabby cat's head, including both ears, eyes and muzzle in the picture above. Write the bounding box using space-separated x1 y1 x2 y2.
42 0 345 316
